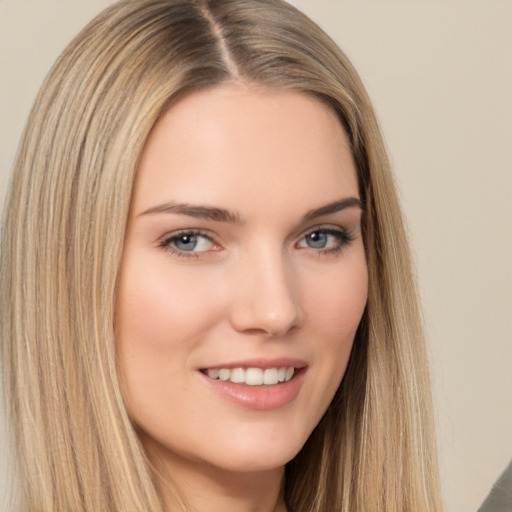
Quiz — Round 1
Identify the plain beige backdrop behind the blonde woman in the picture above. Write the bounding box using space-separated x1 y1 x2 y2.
0 0 512 512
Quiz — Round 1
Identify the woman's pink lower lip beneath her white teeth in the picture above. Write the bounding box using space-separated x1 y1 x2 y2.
199 368 306 411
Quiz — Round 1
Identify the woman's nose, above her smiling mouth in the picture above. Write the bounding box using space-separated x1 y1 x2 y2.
230 251 304 337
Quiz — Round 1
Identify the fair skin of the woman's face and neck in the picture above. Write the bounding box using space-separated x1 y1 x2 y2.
117 84 368 512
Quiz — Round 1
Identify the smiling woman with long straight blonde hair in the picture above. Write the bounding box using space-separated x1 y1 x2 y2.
2 0 441 512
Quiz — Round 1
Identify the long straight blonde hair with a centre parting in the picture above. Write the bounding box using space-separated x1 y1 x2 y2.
1 0 441 512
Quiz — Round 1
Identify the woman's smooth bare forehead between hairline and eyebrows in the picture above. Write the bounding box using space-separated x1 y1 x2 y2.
133 85 358 217
